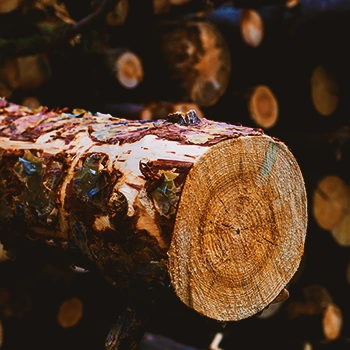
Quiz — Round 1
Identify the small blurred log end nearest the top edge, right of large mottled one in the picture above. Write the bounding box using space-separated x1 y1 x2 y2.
240 9 264 47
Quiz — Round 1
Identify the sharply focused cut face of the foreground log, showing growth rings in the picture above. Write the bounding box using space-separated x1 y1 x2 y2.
168 135 307 321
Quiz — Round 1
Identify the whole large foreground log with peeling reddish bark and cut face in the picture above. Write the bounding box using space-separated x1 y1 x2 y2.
0 100 307 321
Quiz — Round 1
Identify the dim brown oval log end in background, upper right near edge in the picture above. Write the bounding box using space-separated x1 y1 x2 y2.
311 66 339 116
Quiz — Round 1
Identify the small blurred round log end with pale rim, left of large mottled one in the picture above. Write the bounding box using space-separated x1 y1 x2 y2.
114 51 143 89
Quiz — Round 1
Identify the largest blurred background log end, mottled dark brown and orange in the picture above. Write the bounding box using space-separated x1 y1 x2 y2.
162 22 231 107
